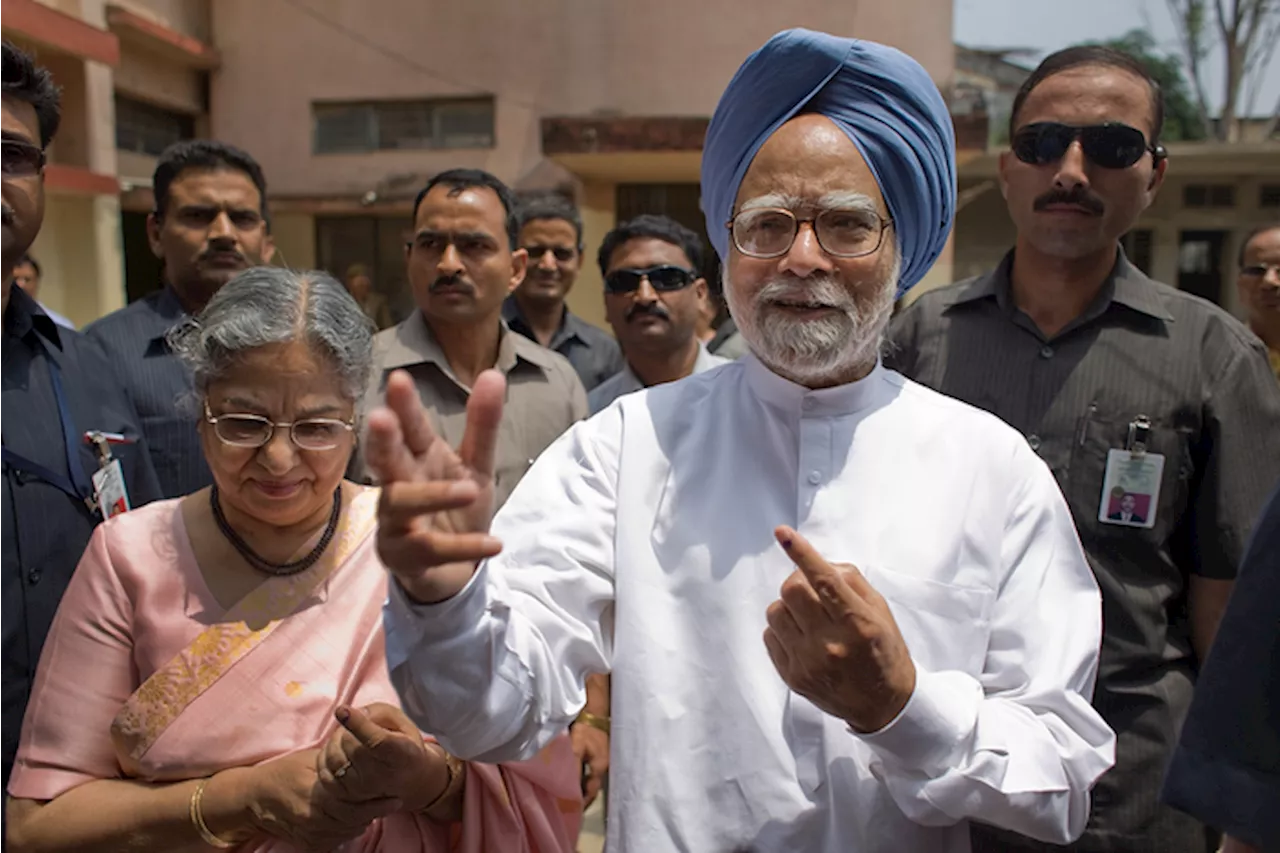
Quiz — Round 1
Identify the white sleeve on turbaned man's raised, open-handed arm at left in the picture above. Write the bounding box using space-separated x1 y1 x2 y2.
385 411 617 762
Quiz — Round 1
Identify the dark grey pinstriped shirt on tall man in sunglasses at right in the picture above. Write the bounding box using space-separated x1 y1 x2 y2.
886 254 1280 853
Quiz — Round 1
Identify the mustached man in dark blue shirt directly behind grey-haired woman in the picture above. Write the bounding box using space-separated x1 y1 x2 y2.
84 140 275 498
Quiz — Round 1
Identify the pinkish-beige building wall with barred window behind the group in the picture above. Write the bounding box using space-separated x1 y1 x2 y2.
211 0 955 325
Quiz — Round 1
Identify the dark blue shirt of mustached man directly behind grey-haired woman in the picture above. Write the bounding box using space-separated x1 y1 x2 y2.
84 287 214 498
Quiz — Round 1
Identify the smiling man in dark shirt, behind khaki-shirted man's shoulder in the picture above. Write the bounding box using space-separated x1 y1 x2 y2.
502 192 623 391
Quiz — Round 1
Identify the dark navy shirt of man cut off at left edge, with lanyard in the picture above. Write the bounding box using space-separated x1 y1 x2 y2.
0 286 160 804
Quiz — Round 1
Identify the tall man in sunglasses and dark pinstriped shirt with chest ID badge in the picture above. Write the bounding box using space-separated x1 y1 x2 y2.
890 47 1280 853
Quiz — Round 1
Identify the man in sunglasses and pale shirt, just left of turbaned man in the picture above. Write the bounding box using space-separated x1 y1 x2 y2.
586 214 728 415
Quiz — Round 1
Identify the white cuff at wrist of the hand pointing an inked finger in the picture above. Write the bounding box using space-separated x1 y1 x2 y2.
850 670 983 776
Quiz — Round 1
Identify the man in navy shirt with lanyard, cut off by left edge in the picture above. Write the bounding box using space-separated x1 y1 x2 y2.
0 42 160 849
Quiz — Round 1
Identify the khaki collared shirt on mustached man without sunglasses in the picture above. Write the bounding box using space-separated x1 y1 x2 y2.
352 311 586 512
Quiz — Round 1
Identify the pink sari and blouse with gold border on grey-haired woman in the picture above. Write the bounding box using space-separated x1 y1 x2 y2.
9 489 581 853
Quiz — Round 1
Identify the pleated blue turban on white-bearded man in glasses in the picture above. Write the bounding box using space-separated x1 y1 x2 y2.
703 29 956 296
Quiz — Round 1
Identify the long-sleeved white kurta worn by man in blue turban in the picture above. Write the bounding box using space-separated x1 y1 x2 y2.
387 356 1115 853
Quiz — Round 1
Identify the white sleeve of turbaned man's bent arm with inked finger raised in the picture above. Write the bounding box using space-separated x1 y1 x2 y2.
864 435 1115 844
